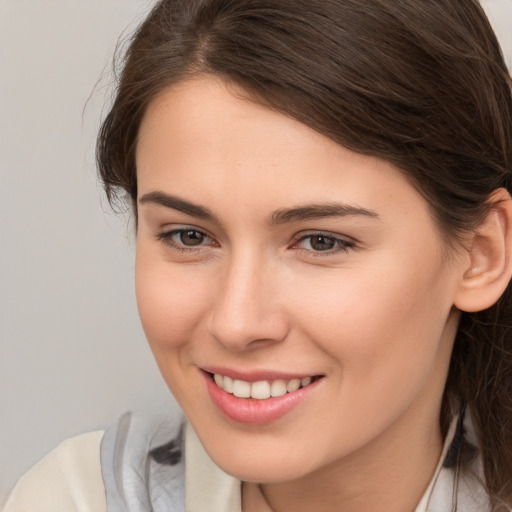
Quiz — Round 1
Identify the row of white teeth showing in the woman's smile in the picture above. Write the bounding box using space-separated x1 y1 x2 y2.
210 373 322 400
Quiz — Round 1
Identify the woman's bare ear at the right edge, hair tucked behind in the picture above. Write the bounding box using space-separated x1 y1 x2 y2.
454 188 512 312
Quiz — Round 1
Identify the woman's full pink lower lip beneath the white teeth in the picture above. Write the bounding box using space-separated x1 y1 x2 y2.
204 373 323 426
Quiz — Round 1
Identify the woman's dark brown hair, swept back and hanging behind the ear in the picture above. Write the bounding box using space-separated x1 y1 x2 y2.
97 0 512 504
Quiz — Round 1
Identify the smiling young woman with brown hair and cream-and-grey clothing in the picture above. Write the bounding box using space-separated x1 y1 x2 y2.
6 0 512 512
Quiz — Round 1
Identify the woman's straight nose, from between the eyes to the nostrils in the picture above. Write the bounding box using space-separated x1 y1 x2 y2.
210 249 289 351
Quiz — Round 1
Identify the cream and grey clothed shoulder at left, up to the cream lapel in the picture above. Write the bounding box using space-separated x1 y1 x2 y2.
4 413 185 512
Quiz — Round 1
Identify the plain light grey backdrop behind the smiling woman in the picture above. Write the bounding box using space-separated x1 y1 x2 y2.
0 0 512 503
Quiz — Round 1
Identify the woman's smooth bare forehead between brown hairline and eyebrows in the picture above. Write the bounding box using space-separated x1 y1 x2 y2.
137 76 427 226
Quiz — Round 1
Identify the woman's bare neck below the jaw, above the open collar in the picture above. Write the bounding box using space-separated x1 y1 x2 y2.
243 408 442 512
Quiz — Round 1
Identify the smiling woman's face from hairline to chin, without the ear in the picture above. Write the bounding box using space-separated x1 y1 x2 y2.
136 77 461 482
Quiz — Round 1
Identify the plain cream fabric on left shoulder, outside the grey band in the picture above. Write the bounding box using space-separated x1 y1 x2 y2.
4 432 107 512
